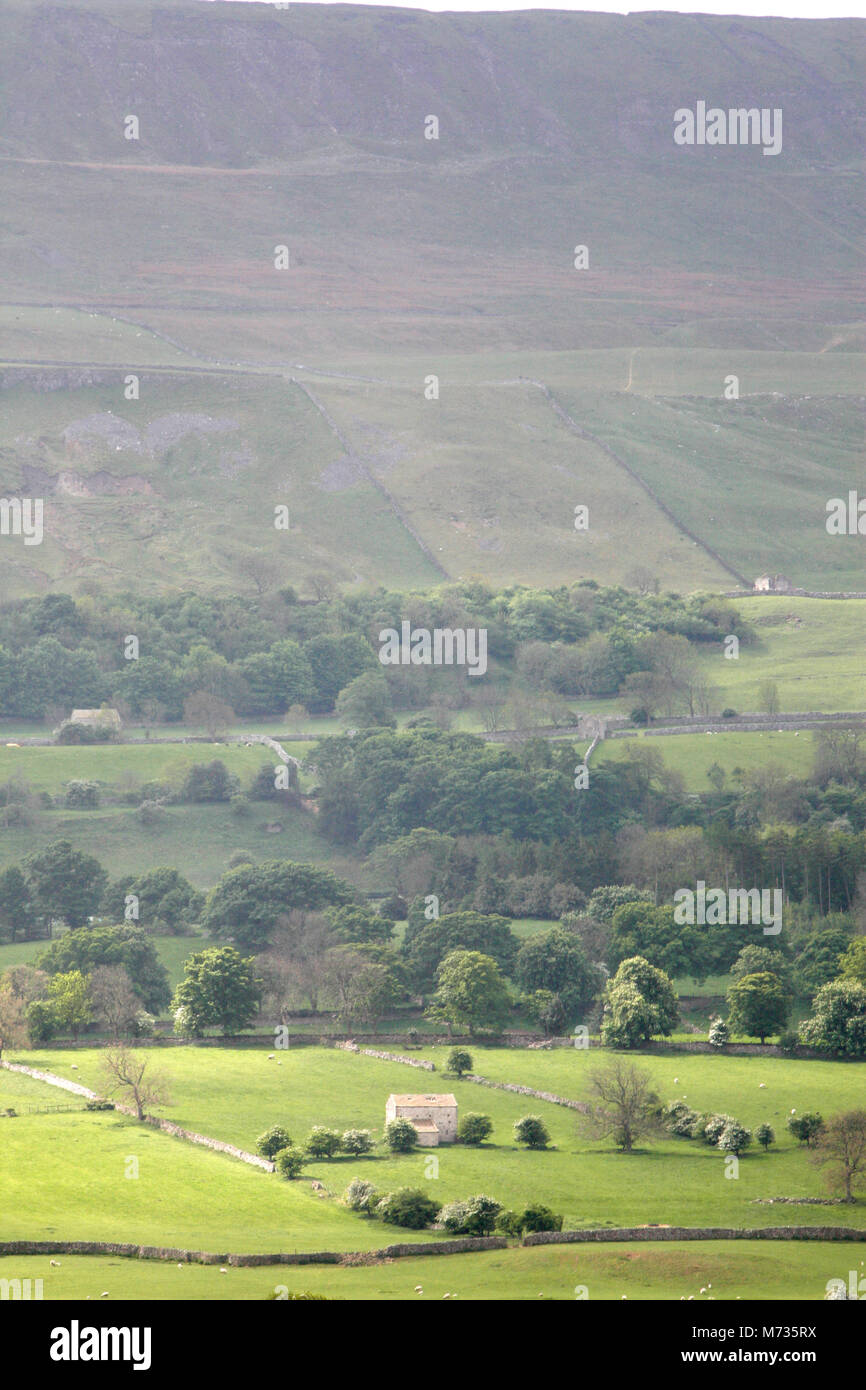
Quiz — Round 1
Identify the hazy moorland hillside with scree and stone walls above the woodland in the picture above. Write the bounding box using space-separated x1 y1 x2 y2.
0 0 866 595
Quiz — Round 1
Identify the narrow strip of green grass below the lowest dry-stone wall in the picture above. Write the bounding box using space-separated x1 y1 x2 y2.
0 1240 866 1306
